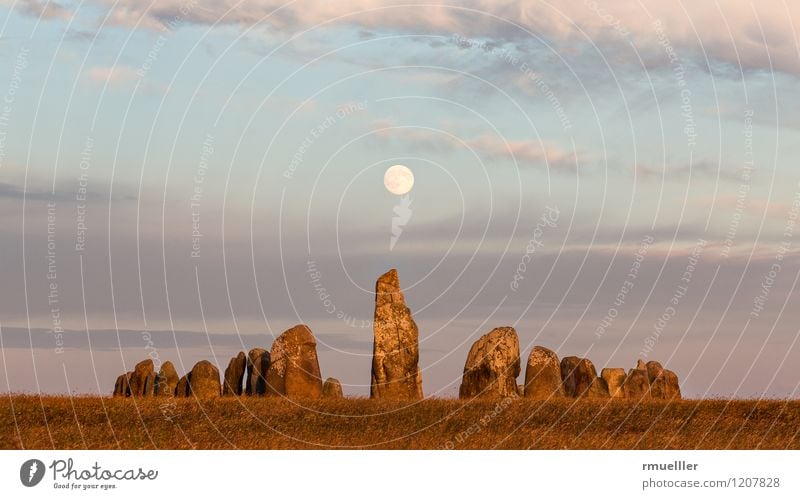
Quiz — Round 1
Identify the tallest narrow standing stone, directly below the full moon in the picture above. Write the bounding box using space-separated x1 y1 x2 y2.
370 269 422 400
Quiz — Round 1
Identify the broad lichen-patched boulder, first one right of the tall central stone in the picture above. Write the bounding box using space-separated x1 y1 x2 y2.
459 327 520 399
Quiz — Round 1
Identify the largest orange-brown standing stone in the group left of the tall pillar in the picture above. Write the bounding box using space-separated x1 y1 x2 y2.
267 324 322 398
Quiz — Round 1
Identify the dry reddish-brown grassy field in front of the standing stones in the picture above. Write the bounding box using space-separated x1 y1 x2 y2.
0 395 800 449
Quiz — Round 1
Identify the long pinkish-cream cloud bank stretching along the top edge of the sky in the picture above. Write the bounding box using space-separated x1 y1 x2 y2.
90 0 800 75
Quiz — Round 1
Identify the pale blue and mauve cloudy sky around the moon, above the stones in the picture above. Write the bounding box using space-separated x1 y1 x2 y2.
0 0 800 398
